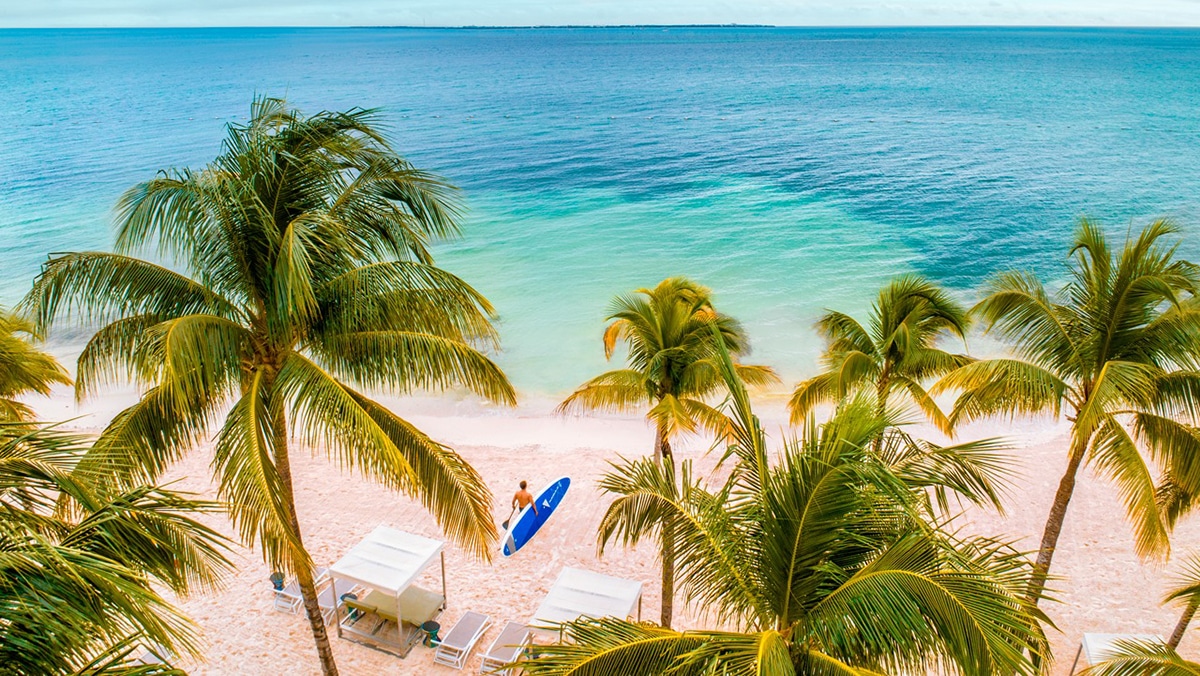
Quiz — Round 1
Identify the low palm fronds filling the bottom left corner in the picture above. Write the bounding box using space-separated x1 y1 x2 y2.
0 423 230 675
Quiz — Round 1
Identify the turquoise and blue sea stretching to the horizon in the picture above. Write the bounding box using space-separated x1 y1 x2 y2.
0 29 1200 394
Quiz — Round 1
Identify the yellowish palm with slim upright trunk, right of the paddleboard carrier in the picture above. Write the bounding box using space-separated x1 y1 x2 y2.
558 277 775 627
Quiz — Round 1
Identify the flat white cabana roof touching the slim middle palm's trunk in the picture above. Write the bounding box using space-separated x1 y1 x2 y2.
533 568 642 624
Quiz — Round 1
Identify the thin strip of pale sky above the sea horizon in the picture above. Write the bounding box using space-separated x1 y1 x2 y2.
0 0 1200 28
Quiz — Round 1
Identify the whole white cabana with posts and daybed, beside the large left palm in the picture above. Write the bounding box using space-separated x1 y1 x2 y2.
329 526 446 656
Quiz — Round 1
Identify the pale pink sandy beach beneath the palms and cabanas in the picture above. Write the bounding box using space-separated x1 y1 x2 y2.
25 391 1200 675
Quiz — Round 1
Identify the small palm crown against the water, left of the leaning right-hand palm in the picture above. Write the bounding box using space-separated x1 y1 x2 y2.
787 275 970 433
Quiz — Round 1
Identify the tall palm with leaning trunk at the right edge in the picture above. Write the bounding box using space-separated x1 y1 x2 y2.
932 220 1200 603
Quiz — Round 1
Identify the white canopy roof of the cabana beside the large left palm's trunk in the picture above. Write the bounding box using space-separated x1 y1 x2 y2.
329 526 445 594
